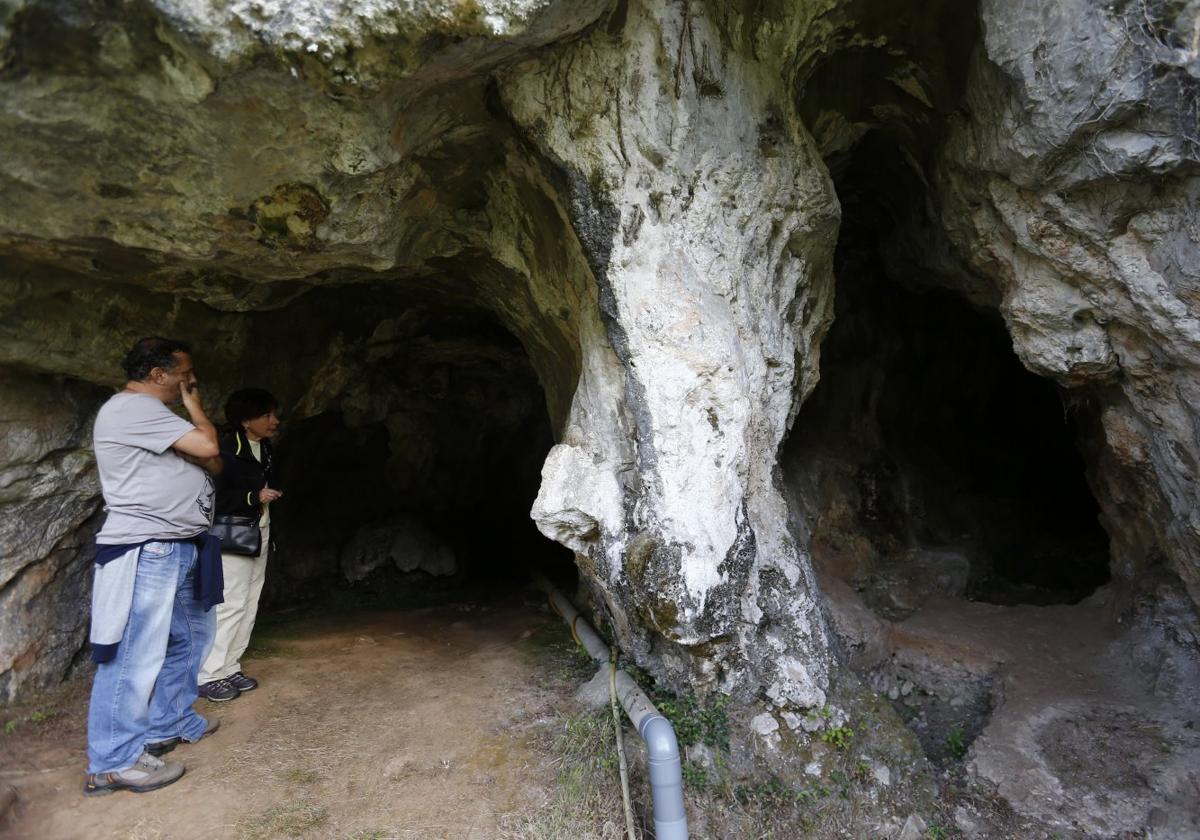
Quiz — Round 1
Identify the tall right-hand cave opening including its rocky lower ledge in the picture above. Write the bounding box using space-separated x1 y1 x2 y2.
782 0 1128 767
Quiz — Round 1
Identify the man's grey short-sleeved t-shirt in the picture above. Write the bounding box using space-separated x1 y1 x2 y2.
92 391 214 545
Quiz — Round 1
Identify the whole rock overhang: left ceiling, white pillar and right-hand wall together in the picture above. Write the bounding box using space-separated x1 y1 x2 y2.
0 0 1198 835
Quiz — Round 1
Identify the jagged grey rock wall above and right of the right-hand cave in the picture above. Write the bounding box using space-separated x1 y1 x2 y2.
787 0 1200 606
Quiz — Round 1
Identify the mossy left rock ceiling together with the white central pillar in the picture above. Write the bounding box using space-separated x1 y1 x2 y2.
0 0 838 707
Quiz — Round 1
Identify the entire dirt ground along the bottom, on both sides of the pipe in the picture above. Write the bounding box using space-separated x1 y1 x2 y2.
9 578 1200 840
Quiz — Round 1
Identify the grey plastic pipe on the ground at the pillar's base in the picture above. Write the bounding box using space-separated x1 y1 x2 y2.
534 575 688 840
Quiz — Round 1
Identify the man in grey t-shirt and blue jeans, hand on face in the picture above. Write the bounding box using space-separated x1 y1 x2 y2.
84 338 221 796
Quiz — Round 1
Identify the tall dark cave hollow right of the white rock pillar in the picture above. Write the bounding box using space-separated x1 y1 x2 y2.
782 0 1109 618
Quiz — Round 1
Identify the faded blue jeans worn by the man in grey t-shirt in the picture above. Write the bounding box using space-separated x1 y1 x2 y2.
88 542 216 773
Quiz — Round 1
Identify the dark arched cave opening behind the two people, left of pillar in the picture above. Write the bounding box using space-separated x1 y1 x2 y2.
244 281 574 606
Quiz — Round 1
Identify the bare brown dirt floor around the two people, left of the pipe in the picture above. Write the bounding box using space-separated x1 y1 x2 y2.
0 596 574 840
